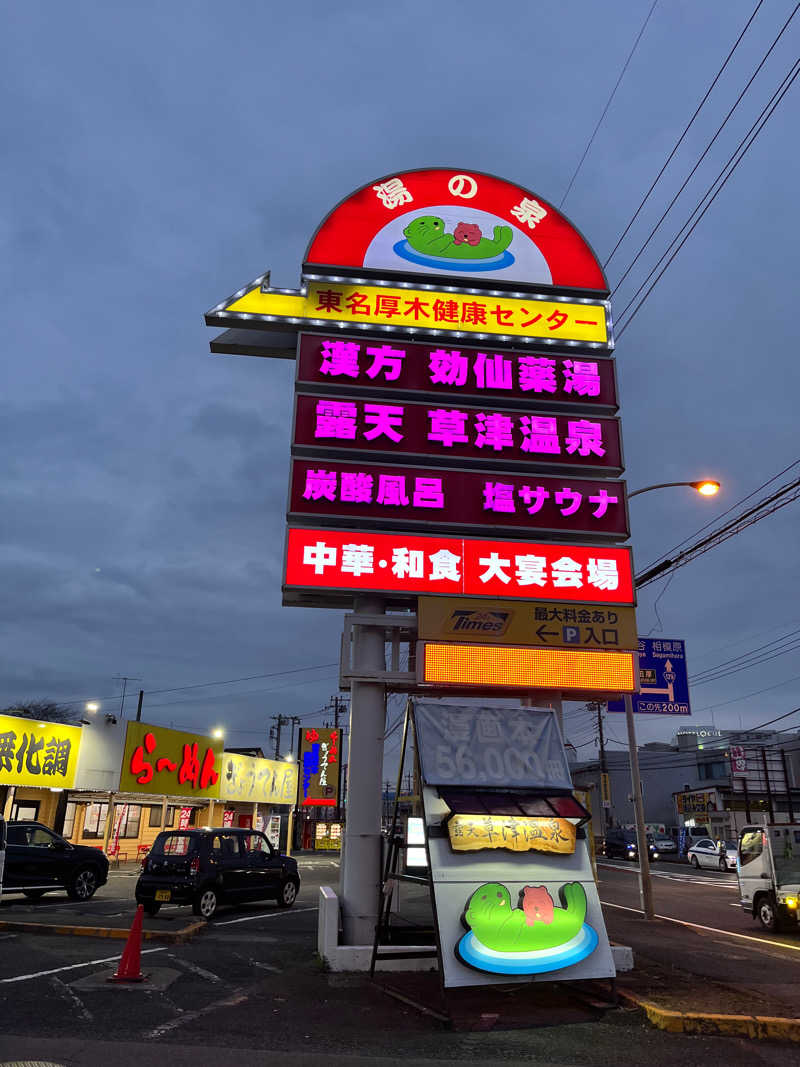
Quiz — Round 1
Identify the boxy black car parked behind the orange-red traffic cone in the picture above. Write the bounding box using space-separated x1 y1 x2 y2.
137 827 300 919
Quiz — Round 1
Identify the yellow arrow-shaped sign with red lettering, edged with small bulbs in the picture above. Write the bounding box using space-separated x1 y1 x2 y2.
216 281 610 347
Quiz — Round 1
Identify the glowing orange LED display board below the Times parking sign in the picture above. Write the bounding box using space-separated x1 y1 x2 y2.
417 641 639 692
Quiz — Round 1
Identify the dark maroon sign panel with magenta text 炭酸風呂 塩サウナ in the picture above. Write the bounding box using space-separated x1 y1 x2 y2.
289 460 629 539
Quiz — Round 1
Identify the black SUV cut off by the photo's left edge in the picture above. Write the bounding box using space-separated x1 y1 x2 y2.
3 823 109 901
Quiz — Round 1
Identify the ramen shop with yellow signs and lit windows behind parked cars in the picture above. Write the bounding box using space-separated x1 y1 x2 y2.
0 716 298 861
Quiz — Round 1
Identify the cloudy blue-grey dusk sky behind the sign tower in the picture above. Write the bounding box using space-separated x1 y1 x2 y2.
0 0 800 768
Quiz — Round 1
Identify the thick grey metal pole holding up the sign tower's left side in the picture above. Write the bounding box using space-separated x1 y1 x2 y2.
340 596 386 944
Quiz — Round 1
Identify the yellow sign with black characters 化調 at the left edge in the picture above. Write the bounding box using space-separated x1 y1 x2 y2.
0 715 81 790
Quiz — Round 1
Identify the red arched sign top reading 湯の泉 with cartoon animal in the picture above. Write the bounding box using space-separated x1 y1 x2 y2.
305 168 608 294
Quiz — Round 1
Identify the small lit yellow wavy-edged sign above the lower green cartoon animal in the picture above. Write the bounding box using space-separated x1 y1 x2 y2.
447 815 577 856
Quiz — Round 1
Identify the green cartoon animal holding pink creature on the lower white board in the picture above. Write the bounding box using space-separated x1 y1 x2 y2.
464 881 587 953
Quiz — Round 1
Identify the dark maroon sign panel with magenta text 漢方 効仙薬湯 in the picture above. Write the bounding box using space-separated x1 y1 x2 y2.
298 334 618 411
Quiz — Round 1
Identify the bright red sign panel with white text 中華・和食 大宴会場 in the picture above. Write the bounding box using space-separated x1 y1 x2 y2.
285 528 635 604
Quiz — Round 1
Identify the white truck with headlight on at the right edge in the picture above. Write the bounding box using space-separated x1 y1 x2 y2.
736 823 800 930
